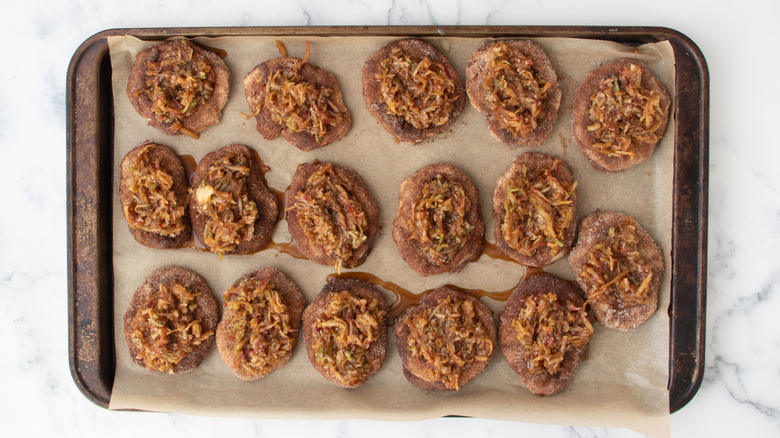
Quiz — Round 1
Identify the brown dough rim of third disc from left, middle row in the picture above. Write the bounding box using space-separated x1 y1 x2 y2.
287 162 379 268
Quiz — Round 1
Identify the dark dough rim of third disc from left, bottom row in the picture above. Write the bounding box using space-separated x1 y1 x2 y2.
303 278 388 388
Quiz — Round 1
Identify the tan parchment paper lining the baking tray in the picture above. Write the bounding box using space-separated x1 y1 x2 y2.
109 37 675 436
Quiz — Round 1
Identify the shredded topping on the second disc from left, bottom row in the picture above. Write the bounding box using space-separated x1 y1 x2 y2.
224 277 297 376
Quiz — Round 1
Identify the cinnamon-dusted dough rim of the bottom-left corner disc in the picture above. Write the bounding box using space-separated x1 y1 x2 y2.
123 266 219 374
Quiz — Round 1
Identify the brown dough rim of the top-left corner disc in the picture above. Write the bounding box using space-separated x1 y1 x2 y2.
127 40 230 135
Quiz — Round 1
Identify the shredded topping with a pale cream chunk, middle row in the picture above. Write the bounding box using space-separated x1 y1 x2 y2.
195 154 258 257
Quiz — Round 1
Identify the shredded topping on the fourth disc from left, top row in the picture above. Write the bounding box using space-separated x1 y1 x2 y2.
485 42 553 138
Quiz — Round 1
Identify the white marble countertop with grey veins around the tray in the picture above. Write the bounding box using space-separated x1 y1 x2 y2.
0 0 780 437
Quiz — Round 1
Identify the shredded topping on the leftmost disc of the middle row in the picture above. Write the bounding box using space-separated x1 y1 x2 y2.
124 143 187 237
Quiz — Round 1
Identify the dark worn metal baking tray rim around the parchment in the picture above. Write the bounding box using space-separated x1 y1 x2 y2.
67 26 709 412
